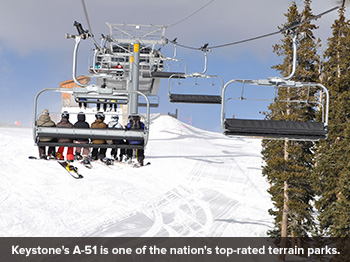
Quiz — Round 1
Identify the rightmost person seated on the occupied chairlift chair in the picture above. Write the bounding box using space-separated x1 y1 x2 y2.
125 115 145 166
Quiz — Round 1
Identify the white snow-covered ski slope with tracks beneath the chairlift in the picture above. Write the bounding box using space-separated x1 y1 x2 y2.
0 115 272 237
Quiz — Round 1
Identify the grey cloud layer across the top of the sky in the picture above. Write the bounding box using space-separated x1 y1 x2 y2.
0 0 342 54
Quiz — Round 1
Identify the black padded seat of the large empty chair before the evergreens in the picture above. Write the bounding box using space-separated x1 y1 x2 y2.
224 119 328 140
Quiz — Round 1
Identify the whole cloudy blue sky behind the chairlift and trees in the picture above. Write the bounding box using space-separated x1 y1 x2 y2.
0 0 346 131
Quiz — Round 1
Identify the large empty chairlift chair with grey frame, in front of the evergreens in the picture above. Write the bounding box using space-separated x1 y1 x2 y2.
221 78 329 141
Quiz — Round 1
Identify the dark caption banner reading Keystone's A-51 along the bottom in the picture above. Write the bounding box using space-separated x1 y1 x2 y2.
0 237 350 262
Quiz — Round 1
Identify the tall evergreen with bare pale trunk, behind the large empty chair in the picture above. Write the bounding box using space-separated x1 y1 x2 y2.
262 0 320 245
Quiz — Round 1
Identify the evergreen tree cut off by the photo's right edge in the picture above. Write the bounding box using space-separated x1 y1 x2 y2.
314 9 350 237
